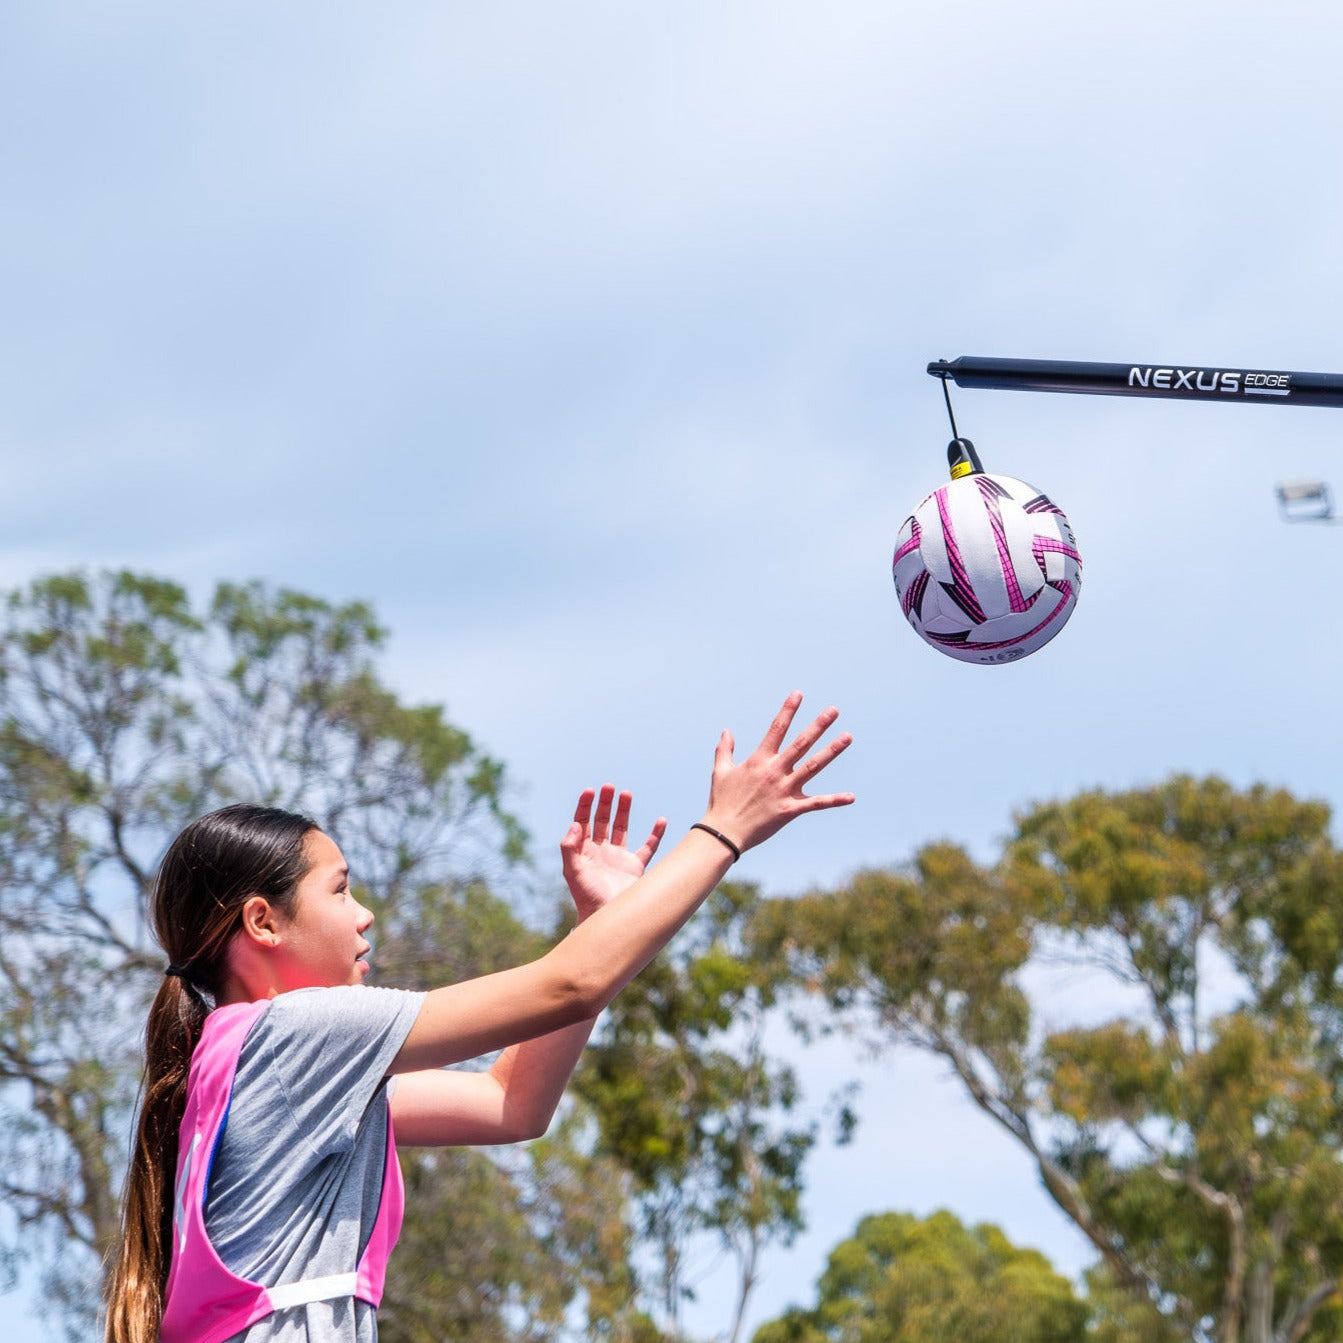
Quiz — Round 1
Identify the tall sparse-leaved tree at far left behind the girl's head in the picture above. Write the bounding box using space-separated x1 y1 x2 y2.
0 572 524 1338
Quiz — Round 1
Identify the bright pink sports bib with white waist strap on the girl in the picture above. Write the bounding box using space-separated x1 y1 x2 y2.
158 1002 406 1343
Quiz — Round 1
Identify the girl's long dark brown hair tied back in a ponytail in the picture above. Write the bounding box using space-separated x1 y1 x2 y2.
105 804 317 1343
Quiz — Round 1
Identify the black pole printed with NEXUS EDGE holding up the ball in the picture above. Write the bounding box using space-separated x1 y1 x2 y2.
928 355 1343 406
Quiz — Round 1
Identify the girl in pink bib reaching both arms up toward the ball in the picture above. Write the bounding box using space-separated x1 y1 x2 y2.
106 694 853 1343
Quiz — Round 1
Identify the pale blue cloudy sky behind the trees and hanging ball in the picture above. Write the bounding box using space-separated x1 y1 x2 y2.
0 0 1343 1343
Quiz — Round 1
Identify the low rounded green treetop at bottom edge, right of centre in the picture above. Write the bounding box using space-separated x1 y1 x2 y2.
753 1211 1088 1343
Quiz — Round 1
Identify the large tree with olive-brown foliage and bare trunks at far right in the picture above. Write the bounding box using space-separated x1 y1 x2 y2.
755 776 1343 1343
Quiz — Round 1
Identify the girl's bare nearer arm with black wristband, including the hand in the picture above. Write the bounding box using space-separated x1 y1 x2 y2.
392 693 854 1073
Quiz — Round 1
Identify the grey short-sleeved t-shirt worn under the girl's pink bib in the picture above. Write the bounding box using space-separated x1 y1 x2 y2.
205 986 424 1343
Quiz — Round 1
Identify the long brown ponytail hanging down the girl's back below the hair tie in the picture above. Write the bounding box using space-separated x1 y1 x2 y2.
105 975 207 1343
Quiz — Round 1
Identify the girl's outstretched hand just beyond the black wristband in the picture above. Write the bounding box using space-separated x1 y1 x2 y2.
704 690 854 850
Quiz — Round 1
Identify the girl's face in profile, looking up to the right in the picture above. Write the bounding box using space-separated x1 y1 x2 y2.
273 830 373 988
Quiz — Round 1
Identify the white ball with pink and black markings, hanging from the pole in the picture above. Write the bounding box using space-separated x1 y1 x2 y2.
892 473 1082 663
